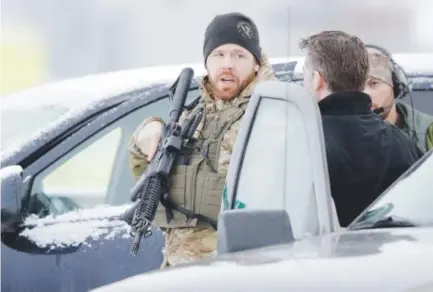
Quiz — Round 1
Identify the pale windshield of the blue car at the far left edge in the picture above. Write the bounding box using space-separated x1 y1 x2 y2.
0 105 70 151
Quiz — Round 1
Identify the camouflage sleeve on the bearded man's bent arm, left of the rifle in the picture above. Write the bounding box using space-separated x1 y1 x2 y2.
128 110 189 180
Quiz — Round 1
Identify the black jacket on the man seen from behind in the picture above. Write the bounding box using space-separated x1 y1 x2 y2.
319 92 423 227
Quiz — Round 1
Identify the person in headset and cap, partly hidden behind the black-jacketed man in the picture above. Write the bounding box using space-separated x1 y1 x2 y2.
364 45 433 152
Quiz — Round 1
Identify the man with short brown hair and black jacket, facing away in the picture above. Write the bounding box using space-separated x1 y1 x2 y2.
300 31 422 227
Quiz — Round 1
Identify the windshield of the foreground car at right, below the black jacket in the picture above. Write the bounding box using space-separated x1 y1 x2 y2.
348 150 433 229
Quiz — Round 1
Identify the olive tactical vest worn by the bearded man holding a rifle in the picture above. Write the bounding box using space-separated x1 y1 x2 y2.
153 101 247 228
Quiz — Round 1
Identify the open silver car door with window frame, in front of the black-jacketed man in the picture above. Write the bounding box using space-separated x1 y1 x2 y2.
223 81 338 239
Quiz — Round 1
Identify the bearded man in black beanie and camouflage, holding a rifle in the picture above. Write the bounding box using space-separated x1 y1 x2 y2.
129 13 276 268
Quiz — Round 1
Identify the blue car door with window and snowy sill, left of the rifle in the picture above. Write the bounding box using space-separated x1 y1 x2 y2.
1 84 198 291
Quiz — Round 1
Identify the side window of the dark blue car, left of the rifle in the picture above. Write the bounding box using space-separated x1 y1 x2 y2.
32 90 198 214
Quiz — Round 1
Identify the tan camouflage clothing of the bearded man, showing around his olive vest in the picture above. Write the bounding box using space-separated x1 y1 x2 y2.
129 56 276 268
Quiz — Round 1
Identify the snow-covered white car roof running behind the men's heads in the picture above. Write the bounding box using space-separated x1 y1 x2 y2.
2 53 433 109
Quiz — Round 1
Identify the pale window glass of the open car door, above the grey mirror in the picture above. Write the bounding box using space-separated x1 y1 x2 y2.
233 98 318 238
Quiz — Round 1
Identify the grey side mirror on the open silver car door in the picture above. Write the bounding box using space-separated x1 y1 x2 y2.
217 209 295 254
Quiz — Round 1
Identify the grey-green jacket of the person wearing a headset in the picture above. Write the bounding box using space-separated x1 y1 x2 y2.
396 102 433 152
